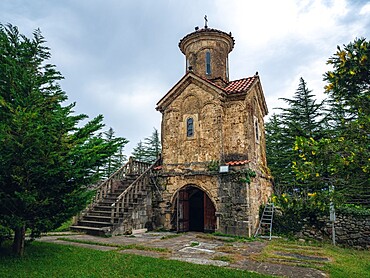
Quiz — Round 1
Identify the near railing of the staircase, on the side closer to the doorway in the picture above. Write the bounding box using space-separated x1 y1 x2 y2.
111 158 161 224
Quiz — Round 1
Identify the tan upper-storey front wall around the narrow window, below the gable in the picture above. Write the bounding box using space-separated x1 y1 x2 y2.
162 81 222 166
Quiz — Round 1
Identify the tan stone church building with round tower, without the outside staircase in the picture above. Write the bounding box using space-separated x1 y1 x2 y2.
155 28 272 236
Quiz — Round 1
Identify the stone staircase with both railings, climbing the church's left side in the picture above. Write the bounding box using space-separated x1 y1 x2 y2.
70 158 159 235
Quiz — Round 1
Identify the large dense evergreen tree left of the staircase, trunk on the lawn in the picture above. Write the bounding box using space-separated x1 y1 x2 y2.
0 25 124 255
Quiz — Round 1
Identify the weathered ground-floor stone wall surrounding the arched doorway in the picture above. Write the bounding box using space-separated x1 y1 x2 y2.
154 165 272 236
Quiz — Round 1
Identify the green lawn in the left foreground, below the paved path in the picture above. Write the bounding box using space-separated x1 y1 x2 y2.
0 242 271 278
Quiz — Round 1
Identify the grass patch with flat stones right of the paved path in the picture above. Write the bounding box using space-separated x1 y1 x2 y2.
254 240 370 278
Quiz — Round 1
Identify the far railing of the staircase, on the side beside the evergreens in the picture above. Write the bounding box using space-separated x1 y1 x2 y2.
88 157 151 212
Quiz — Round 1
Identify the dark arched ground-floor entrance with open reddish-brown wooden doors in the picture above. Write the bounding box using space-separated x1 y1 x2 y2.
173 186 216 232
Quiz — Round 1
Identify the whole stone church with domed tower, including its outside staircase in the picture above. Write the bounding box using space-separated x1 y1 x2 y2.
72 25 272 236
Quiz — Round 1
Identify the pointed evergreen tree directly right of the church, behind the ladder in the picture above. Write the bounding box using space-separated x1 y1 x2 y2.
266 78 326 193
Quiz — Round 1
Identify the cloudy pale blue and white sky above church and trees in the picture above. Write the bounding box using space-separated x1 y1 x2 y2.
0 0 370 155
